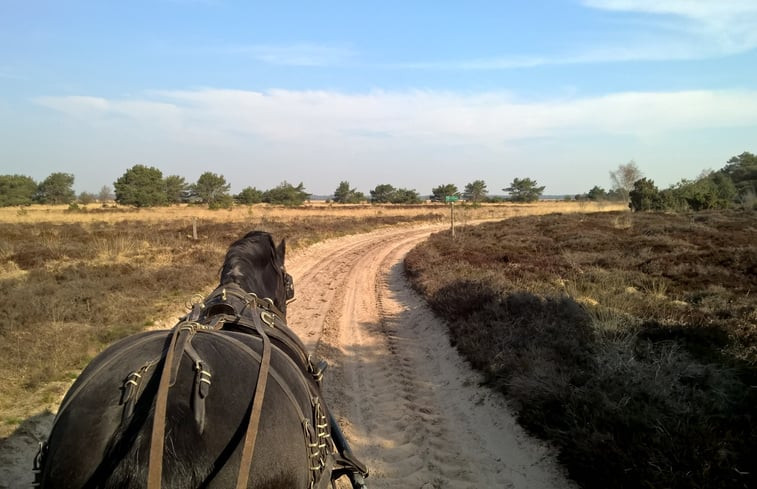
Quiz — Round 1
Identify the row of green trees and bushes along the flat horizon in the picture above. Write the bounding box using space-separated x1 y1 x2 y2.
0 152 757 211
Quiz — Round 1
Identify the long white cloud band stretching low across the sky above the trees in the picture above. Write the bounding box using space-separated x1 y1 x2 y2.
36 89 757 147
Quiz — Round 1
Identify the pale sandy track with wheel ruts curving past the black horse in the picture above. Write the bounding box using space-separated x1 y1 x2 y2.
0 226 573 489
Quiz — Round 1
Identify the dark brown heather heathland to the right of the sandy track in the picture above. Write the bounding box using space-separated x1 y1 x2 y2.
406 211 757 489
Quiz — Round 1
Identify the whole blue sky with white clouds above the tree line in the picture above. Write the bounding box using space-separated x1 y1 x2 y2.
0 0 757 194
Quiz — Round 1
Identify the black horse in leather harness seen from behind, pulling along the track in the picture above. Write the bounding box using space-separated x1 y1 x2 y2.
35 231 367 489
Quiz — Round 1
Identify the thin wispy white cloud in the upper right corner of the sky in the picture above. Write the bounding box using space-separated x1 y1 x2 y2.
396 0 757 71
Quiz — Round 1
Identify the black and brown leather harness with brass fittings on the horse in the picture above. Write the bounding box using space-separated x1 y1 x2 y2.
34 284 368 489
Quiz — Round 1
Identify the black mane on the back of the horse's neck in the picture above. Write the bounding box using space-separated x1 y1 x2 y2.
221 231 276 288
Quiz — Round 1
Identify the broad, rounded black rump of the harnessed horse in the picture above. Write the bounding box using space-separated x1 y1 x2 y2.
41 329 333 488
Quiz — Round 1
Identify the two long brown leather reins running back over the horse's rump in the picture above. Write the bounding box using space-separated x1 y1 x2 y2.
147 288 283 489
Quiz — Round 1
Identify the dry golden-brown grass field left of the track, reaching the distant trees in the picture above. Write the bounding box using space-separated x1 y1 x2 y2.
0 202 620 438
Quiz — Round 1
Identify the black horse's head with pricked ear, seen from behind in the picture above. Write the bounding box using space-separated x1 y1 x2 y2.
220 231 294 319
